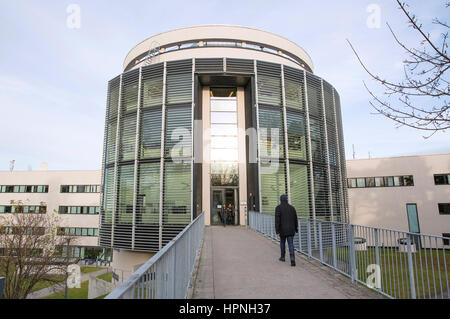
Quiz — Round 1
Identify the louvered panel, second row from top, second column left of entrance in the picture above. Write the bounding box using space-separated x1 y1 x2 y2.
140 107 162 158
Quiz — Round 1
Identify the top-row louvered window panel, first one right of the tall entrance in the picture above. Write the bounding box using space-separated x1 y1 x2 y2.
257 61 282 106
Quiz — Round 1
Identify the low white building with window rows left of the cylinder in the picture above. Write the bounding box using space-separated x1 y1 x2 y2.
0 170 111 261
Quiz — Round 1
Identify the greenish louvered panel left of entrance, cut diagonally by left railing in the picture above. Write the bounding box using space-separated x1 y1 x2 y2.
162 162 192 246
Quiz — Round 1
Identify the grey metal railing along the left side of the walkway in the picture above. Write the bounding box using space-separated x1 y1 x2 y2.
105 213 205 299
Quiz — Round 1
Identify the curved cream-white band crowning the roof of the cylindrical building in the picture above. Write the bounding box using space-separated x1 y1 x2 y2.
123 25 314 71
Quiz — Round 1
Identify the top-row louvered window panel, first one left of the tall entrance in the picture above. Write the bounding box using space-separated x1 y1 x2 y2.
166 60 192 105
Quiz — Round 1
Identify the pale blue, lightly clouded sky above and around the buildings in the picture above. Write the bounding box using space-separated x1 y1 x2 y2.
0 0 450 170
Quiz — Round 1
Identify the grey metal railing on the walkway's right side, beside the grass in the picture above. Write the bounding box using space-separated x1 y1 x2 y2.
249 212 450 299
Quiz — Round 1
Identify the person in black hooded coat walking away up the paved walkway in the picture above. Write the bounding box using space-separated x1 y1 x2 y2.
275 195 298 266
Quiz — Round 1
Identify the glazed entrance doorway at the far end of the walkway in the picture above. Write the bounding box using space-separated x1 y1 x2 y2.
211 187 239 225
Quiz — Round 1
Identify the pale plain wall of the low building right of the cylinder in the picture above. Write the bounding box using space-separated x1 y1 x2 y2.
347 154 450 236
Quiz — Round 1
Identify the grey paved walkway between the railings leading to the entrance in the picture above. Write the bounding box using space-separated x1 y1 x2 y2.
192 226 377 299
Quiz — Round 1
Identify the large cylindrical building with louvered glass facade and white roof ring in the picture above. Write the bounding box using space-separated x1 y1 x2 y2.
100 25 348 276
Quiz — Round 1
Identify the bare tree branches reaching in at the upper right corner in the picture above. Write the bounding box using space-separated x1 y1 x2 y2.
347 0 450 137
